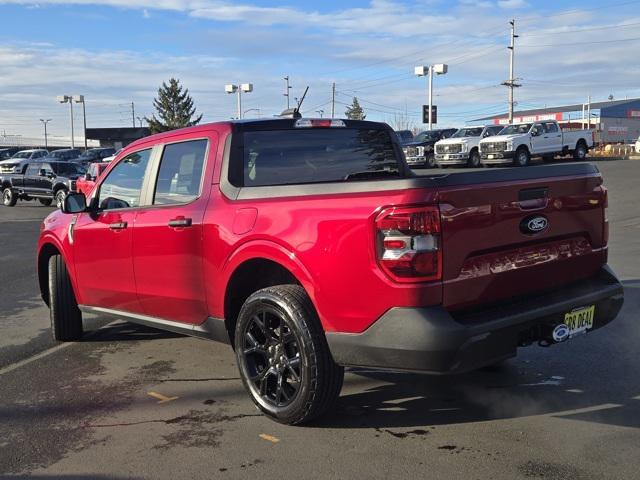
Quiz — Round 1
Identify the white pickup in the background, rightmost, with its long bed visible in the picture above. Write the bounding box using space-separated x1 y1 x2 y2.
480 120 593 167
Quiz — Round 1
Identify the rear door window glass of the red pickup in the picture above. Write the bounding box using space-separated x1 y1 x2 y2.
153 140 207 205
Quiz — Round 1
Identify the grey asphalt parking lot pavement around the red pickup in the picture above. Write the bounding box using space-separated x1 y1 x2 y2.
0 161 640 480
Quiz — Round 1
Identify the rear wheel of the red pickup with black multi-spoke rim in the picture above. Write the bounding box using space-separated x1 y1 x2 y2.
234 285 344 425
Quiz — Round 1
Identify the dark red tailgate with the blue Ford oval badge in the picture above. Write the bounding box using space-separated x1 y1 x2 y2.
438 167 607 310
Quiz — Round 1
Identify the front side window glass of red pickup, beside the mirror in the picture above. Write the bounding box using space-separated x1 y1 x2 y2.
98 149 151 210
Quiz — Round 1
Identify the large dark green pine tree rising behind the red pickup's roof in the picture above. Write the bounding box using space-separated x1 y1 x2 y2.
145 78 202 133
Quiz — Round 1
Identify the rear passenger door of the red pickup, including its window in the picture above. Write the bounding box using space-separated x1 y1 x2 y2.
133 133 217 324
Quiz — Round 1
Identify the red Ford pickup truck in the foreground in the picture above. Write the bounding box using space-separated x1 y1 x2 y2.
37 118 623 424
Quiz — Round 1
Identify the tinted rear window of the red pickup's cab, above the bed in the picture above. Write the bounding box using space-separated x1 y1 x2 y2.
231 128 403 187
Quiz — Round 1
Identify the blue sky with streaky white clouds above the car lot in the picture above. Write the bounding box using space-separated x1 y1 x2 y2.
0 0 640 142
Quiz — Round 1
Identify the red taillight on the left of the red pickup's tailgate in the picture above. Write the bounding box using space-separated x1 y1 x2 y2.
375 206 442 282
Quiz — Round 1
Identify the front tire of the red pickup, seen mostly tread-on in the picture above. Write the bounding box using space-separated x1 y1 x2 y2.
49 255 82 342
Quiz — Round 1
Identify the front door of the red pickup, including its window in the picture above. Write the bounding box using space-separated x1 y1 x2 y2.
70 148 152 313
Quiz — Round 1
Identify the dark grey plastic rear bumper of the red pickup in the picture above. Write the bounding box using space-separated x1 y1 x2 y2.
326 266 624 374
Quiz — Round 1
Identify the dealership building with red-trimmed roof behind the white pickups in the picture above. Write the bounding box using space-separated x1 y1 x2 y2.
473 98 640 143
